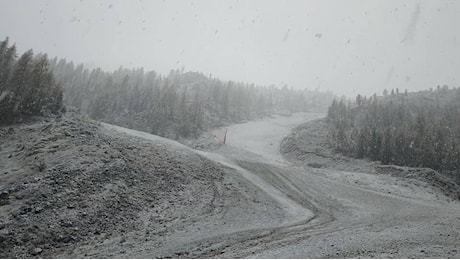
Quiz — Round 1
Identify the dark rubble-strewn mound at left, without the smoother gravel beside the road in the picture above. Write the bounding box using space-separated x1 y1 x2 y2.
0 116 224 258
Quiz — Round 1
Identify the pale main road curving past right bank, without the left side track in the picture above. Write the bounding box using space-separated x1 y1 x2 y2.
204 114 460 258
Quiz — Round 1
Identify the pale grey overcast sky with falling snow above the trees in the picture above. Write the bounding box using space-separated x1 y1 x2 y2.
0 0 460 95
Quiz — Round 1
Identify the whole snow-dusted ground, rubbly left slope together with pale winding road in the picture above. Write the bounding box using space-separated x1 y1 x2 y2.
0 113 460 258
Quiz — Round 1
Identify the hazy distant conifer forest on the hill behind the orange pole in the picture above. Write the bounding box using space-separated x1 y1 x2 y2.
51 58 333 139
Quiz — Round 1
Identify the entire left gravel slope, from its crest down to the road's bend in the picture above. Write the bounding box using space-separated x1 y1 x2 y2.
0 116 284 258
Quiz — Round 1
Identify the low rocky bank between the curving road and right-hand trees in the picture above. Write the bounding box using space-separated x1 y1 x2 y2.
280 118 460 199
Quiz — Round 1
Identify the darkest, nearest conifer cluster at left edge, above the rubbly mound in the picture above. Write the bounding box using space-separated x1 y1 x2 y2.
0 38 62 124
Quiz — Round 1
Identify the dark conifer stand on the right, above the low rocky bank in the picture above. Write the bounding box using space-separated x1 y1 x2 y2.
328 86 460 174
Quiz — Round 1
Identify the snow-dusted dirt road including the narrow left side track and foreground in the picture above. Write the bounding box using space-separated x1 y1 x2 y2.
105 113 460 258
